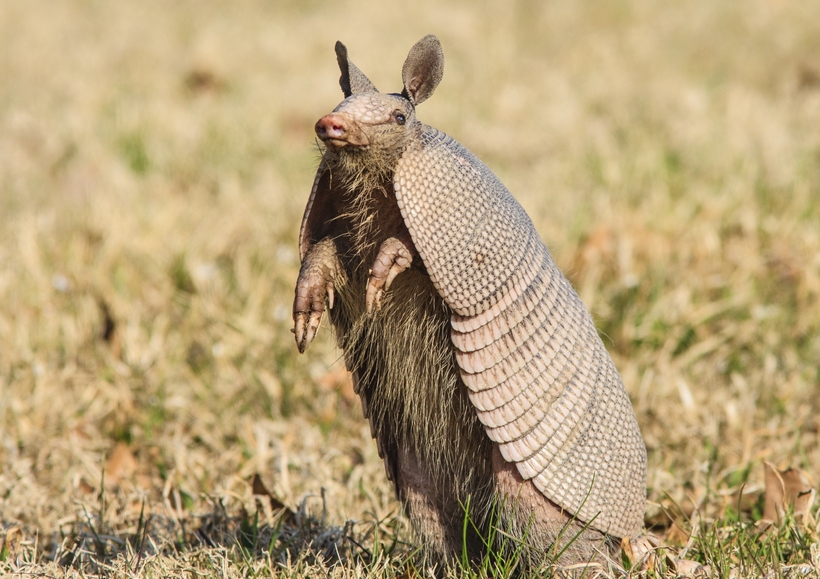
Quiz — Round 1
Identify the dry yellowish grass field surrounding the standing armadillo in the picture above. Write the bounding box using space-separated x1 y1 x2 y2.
0 0 820 577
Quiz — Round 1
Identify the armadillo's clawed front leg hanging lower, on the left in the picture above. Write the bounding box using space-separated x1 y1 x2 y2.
293 238 339 352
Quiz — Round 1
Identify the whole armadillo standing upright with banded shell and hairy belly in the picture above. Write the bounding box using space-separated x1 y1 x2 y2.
293 36 646 565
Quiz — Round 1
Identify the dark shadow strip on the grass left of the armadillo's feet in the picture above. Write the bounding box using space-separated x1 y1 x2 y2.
0 497 415 576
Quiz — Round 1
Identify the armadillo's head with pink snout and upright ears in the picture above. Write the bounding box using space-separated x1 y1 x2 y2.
315 35 444 170
